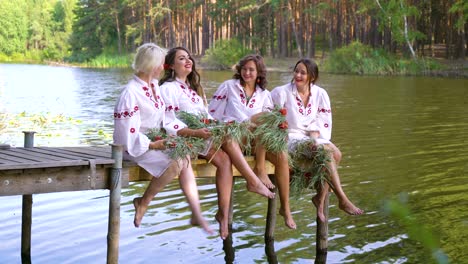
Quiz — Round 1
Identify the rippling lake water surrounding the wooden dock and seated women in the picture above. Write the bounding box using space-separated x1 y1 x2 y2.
0 64 468 263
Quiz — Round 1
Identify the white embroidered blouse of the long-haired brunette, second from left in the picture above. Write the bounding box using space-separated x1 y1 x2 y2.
161 80 213 131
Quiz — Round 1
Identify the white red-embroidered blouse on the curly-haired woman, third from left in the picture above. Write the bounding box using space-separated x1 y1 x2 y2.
208 79 273 122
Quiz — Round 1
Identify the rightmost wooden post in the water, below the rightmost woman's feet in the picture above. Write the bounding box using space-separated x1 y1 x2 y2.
315 193 330 264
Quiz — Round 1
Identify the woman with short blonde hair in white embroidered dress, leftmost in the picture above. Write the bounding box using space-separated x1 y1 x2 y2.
114 43 212 233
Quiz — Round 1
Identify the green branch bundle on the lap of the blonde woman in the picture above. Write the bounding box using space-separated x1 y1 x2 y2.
146 128 205 160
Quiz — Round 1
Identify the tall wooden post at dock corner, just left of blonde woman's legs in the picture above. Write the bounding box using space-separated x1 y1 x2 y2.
107 144 123 263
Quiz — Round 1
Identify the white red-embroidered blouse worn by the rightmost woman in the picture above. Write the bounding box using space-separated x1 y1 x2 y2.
271 83 332 144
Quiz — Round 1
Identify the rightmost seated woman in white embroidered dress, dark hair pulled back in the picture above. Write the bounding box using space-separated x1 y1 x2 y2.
271 59 363 221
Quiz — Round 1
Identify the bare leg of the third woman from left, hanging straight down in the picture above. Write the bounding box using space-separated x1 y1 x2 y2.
266 152 296 229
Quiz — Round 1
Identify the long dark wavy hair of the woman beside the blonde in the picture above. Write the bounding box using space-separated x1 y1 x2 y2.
159 47 206 104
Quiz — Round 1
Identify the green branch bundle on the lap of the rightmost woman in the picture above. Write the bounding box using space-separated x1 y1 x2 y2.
289 139 334 195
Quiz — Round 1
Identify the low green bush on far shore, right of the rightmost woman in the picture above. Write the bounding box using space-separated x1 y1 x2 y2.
324 42 441 75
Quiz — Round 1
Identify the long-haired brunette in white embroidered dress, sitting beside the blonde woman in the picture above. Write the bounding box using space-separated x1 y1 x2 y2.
160 47 274 239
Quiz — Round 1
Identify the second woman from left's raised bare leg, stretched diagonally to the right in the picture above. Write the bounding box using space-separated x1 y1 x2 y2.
223 140 275 199
